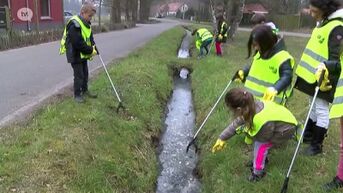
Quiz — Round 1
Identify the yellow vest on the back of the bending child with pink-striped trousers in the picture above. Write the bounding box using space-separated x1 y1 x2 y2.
247 101 298 137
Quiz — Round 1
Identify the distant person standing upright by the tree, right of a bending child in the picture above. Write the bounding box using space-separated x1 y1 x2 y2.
216 15 228 56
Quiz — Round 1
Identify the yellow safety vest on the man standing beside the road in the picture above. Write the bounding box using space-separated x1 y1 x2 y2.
60 15 92 59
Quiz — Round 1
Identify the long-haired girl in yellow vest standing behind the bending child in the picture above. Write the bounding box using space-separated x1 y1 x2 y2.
233 25 294 104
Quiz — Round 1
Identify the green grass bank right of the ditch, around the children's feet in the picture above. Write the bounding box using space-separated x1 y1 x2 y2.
192 32 339 193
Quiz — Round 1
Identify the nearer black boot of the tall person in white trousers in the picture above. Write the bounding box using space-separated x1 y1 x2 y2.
305 126 327 156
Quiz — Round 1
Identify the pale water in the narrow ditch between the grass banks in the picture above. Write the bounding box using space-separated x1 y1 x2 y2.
156 32 200 193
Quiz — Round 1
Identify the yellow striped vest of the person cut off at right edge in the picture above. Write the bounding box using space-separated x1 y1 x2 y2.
330 76 343 119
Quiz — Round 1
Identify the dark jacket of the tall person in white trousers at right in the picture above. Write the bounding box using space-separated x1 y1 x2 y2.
295 18 343 102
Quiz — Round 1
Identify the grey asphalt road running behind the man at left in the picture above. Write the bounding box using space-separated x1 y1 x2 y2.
0 20 180 128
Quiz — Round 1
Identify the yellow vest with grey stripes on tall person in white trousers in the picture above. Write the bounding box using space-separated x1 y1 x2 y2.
295 20 343 84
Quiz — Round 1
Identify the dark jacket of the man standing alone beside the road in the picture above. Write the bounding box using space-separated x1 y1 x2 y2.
66 16 95 64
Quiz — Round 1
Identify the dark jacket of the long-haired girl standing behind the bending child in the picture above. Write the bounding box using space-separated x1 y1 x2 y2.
243 38 293 93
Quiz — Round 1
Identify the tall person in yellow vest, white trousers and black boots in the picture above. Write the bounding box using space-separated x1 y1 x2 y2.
295 0 343 157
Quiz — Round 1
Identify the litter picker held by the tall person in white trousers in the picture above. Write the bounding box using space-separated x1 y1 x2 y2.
281 70 325 193
